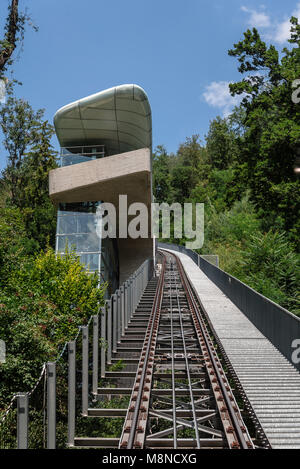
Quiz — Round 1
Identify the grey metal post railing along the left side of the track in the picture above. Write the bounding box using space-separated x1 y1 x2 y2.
0 259 153 449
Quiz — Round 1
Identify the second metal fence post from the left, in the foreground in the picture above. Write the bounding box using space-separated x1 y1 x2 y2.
47 362 56 449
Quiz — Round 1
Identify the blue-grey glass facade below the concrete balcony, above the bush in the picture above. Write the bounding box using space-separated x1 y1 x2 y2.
56 202 119 295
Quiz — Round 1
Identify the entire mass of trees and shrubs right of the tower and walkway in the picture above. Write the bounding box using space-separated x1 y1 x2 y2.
153 18 300 314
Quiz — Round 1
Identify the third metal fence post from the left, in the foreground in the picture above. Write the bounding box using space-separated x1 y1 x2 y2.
68 340 76 446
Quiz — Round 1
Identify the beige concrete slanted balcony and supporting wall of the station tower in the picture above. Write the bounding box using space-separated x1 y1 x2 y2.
49 148 153 283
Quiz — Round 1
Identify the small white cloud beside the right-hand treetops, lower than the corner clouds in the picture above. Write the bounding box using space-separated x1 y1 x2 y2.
203 81 242 117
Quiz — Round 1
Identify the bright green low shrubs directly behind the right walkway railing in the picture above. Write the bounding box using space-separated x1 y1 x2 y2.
201 196 300 314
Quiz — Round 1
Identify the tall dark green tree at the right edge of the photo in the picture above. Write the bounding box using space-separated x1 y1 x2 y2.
229 17 300 247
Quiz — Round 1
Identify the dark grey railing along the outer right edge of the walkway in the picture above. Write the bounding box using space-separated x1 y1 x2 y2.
158 243 300 371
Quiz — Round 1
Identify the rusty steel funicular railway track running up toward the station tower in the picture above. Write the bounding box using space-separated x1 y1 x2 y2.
75 251 264 449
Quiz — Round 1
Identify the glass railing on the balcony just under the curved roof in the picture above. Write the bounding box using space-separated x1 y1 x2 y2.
60 145 105 166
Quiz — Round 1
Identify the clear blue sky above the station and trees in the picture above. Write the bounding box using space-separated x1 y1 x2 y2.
0 0 300 168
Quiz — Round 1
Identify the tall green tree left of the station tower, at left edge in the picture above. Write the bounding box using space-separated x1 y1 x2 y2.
0 97 57 249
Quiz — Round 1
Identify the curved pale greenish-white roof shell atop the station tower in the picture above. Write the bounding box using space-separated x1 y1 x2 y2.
54 85 152 155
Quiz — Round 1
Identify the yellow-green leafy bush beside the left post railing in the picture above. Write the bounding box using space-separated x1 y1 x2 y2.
0 249 105 402
